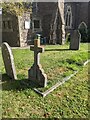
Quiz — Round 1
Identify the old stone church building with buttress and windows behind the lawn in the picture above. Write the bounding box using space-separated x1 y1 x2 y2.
2 2 90 47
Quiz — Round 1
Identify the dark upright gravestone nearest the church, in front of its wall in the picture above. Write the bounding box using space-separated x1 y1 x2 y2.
70 30 81 50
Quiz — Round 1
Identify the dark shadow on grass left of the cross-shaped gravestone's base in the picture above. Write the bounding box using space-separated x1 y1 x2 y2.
2 74 40 91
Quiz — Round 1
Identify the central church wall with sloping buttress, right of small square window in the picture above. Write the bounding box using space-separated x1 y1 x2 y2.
32 2 65 44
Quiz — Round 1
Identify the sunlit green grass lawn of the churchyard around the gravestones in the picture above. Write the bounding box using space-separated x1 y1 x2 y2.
0 43 89 118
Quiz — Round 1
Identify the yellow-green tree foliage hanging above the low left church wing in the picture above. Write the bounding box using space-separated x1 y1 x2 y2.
1 2 32 16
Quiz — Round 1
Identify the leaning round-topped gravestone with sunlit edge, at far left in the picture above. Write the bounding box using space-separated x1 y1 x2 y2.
2 42 17 80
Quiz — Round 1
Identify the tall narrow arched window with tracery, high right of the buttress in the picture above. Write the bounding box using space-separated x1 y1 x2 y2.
65 6 72 28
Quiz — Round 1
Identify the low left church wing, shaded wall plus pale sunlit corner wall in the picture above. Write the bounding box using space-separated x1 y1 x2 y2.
2 13 31 47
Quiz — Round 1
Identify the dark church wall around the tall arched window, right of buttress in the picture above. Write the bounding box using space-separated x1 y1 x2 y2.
64 2 88 33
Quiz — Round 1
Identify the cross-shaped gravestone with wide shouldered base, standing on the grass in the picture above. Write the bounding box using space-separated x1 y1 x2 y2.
28 39 47 87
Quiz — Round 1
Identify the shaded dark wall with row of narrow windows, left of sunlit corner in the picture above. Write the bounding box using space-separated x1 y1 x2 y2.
2 13 20 47
